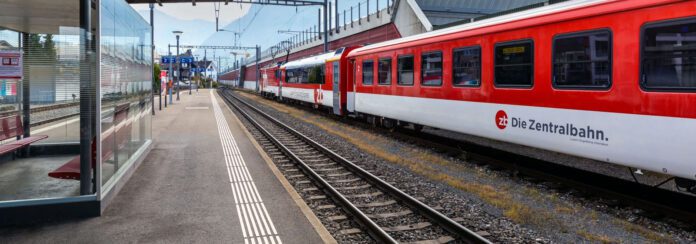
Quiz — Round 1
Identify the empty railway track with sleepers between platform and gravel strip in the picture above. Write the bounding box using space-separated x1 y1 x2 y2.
220 88 490 243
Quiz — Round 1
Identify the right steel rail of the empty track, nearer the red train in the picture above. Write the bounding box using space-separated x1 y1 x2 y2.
222 90 491 243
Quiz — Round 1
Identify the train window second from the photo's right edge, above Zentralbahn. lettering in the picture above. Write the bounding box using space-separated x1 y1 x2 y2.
553 30 612 89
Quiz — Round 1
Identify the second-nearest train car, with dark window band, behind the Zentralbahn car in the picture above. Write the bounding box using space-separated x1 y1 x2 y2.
277 47 356 115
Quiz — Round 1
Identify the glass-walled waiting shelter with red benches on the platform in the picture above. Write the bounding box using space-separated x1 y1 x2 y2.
0 0 153 225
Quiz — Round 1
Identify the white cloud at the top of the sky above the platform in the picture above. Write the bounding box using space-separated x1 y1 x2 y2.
131 3 251 26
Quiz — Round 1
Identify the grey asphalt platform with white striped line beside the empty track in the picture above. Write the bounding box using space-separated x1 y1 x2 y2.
0 89 333 243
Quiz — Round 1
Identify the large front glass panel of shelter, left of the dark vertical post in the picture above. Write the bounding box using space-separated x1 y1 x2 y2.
0 1 97 201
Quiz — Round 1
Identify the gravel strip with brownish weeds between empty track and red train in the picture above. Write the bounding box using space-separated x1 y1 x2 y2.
232 90 696 243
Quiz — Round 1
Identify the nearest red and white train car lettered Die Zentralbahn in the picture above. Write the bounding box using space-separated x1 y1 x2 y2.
347 0 696 186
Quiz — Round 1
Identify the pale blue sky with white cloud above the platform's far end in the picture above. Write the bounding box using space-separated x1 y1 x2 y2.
131 0 370 69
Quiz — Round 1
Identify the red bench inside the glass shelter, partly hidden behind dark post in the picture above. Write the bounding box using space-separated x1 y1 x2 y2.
48 105 132 180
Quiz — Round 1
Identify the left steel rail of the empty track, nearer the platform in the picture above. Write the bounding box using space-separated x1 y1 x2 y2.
222 89 398 243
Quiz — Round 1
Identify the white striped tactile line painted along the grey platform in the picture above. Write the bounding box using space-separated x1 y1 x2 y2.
209 90 282 244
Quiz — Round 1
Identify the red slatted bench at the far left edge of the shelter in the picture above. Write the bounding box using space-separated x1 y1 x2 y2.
0 115 48 155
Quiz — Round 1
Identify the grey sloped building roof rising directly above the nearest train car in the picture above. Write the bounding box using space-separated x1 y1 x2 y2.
416 0 546 26
